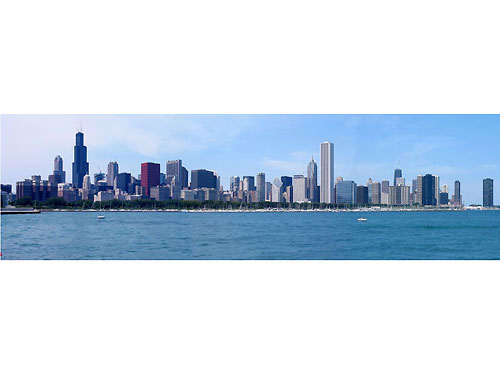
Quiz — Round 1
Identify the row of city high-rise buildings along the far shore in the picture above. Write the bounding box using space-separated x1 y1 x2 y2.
2 131 493 207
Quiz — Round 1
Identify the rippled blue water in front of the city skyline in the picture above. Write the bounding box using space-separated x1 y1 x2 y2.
2 211 500 260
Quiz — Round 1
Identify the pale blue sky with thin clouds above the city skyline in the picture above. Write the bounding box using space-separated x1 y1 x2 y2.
1 115 500 204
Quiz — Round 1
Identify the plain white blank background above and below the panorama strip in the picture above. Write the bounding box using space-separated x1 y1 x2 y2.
0 0 500 375
